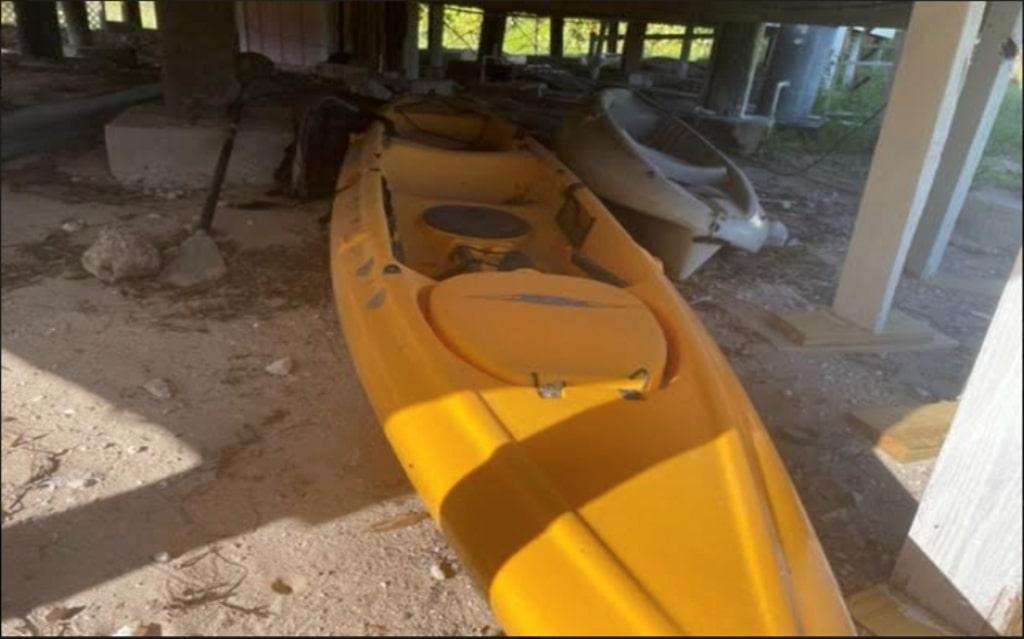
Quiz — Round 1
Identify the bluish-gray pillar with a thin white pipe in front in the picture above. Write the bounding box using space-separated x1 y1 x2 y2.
758 25 837 122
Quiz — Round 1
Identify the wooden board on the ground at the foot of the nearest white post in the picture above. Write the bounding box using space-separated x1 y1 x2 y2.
846 585 959 637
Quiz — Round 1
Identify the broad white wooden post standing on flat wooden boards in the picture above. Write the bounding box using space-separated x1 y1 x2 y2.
833 2 985 333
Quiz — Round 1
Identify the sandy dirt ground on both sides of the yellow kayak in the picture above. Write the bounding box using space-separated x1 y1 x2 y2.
0 90 1020 635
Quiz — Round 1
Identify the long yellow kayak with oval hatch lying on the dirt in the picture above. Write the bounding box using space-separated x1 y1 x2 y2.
331 98 854 635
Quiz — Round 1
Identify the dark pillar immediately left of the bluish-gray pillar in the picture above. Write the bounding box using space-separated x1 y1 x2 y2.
705 23 764 116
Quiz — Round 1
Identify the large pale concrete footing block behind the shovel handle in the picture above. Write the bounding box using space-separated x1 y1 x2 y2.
105 104 293 188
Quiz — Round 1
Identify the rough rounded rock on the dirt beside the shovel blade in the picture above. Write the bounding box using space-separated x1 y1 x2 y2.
82 225 160 284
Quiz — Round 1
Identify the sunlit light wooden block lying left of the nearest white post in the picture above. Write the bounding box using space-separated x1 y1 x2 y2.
851 401 956 462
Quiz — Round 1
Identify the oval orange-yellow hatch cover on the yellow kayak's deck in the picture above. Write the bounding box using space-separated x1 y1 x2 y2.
427 269 668 391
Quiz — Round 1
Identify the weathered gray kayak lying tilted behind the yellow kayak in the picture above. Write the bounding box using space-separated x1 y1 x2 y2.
556 89 786 278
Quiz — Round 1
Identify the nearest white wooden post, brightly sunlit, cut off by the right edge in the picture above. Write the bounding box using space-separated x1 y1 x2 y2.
892 253 1022 635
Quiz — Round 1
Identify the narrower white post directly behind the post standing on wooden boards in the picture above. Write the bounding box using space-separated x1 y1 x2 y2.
906 2 1021 279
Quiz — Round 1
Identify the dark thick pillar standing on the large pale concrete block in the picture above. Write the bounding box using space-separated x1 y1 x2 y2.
157 0 239 117
